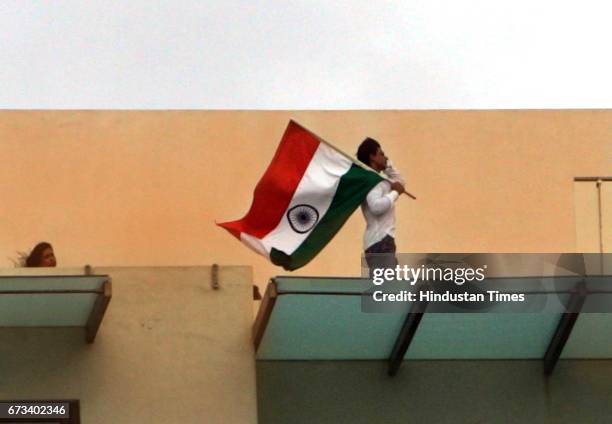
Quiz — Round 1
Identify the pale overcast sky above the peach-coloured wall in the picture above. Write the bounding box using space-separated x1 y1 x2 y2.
0 0 612 109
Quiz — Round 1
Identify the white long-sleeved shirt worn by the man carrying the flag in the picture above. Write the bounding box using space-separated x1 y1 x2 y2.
361 161 405 250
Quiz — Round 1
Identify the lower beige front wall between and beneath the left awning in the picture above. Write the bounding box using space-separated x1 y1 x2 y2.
0 267 257 424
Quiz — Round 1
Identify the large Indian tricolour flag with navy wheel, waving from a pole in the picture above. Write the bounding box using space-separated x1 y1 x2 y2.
218 121 382 270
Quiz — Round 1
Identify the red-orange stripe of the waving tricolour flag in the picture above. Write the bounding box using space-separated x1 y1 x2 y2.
217 121 320 239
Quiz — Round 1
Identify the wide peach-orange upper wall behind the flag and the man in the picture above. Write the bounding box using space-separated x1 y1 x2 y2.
0 110 612 286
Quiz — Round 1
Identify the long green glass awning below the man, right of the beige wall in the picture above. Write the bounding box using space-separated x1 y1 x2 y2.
254 276 612 368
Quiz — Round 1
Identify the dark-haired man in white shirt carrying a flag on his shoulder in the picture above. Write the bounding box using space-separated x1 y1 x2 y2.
357 137 405 275
